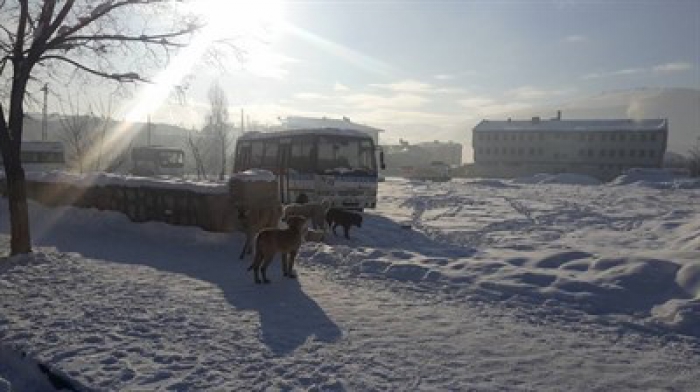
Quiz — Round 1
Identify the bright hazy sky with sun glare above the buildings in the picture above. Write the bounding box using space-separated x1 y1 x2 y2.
45 0 700 141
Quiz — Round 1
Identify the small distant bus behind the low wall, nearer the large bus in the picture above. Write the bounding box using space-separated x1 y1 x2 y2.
131 146 185 177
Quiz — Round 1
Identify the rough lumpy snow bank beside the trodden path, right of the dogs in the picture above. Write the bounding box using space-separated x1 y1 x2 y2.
304 179 700 336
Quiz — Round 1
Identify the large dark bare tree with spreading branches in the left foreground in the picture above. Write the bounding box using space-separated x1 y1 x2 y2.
0 0 201 255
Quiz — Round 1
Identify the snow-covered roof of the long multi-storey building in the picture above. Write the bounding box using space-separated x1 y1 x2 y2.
474 117 668 132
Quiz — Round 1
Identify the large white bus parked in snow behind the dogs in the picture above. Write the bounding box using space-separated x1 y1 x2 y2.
234 128 384 210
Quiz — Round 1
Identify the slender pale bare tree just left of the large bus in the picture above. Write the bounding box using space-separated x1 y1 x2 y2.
205 83 232 180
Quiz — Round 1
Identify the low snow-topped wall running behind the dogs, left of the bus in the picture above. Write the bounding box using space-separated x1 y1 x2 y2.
0 175 240 232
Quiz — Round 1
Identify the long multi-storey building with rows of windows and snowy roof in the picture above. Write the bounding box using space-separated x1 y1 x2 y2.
471 112 668 180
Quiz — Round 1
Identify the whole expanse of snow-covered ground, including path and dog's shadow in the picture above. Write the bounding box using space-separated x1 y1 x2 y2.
0 173 700 391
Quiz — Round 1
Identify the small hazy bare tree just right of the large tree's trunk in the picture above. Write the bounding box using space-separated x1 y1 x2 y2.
60 97 95 174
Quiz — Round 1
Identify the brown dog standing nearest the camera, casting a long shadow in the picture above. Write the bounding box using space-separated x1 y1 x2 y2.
248 215 306 283
